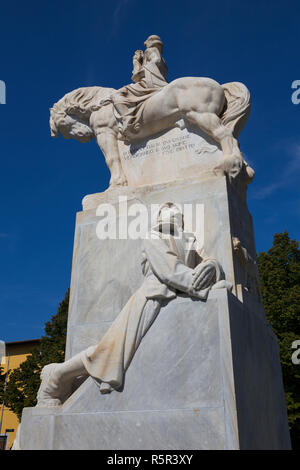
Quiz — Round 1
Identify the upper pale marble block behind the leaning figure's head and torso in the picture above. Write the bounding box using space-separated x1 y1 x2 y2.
66 175 265 359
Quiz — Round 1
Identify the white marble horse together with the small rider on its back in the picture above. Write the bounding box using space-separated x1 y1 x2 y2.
50 35 254 188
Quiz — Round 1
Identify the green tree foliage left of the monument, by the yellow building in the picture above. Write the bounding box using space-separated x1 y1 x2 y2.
0 290 69 419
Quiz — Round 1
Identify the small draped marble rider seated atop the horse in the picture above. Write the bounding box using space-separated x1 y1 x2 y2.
105 35 168 140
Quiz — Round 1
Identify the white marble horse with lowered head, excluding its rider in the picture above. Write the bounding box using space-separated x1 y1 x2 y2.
50 77 254 188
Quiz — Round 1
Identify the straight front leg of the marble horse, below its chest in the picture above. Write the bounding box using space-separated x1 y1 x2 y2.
97 129 128 188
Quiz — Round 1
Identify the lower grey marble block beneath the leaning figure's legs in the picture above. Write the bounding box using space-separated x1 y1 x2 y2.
19 289 290 450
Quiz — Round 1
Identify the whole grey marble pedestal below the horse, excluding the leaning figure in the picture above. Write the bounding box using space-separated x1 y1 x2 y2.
19 172 290 450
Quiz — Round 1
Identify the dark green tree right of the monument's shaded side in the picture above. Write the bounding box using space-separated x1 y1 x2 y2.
257 231 300 449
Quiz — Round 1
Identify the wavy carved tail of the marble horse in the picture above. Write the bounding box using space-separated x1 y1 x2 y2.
220 82 251 138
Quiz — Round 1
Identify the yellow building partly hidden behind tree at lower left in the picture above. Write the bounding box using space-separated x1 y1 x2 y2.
0 340 39 450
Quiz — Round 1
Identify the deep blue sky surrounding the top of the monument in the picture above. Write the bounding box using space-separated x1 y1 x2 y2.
0 0 300 341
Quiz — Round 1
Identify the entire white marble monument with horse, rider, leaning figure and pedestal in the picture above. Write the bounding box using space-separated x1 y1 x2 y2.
14 35 290 450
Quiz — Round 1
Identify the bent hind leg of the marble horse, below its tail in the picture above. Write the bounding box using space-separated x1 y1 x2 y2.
185 111 244 178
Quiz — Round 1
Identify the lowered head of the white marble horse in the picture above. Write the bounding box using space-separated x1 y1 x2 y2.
50 105 95 143
